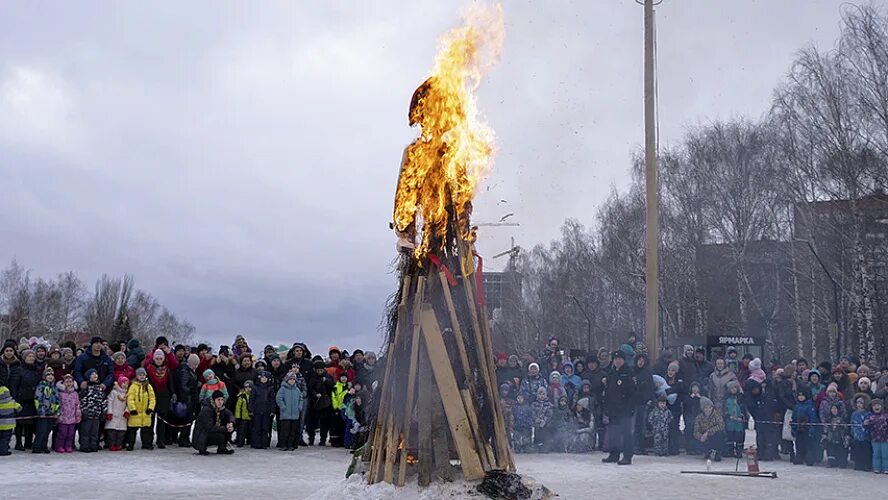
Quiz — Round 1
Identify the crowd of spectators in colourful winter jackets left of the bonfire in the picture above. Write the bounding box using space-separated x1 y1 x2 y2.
0 335 381 456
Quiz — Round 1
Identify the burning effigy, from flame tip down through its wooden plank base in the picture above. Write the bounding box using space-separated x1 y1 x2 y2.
365 6 514 486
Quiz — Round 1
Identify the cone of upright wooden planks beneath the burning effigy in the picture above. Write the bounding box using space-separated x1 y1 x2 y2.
369 236 514 486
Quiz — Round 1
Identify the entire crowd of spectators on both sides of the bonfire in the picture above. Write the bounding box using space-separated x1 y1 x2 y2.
0 336 888 473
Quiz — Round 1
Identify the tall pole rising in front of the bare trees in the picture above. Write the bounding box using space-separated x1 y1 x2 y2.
644 0 660 356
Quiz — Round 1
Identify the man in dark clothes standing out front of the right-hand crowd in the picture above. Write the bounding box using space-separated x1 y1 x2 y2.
601 351 637 465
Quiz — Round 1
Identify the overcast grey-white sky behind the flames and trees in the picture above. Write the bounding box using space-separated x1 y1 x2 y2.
0 0 840 349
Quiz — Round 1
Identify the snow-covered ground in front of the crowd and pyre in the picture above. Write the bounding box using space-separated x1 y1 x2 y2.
0 447 888 500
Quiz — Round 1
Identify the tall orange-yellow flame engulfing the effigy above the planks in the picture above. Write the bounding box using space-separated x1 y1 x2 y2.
393 5 504 259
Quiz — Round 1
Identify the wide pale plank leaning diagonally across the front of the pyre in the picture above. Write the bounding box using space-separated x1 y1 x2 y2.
422 307 484 481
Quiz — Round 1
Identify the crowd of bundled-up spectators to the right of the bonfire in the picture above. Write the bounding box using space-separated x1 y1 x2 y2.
497 336 888 474
